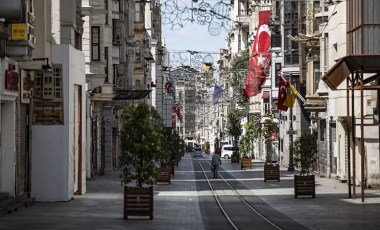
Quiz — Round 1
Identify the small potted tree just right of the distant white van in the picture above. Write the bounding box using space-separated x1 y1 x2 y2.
226 109 243 164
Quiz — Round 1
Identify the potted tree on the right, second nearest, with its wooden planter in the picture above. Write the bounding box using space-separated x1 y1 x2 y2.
261 116 280 182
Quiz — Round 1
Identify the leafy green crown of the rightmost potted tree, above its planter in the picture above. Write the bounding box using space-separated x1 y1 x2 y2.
293 133 318 175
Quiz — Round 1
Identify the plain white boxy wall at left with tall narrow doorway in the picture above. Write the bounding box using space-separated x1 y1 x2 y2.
31 45 86 201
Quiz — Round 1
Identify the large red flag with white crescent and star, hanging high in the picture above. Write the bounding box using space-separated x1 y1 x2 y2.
244 10 271 98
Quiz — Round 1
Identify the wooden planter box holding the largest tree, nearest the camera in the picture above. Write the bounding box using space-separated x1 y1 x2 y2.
124 186 154 220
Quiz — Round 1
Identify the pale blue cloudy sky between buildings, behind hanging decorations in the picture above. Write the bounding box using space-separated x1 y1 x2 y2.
161 0 227 61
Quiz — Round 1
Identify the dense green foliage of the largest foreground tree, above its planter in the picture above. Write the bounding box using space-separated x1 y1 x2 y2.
120 103 166 187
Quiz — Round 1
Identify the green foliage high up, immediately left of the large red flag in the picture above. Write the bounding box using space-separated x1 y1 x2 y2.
229 49 249 107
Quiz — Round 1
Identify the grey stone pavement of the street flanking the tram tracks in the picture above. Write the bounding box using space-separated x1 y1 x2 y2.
0 153 380 230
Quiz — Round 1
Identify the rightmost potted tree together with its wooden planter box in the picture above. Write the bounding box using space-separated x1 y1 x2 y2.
293 133 318 198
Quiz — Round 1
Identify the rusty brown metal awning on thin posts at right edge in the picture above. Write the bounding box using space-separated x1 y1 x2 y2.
322 54 380 90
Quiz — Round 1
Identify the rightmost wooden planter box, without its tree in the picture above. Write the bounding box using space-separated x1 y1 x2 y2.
294 175 315 198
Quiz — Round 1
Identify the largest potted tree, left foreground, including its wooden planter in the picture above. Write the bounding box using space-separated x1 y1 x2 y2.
120 103 164 219
